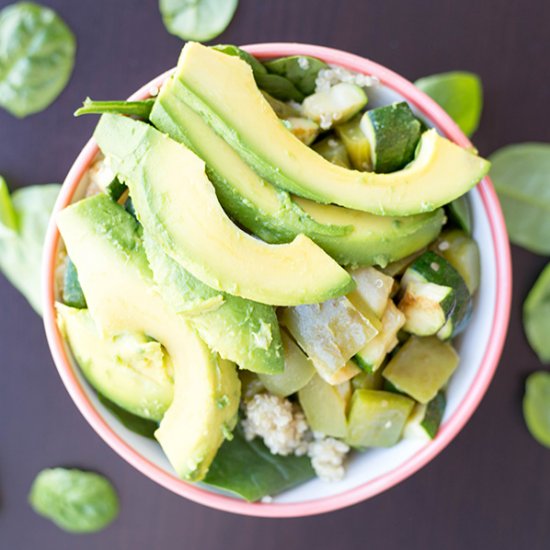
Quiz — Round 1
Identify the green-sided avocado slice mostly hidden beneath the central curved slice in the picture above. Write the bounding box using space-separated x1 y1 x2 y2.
143 234 284 374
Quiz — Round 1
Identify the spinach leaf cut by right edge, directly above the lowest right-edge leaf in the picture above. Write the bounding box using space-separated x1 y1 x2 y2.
523 264 550 364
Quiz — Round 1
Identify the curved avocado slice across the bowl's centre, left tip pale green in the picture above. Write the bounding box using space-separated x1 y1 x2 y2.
94 115 354 306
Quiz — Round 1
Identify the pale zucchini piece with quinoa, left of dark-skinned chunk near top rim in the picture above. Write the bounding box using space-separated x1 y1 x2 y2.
302 82 367 130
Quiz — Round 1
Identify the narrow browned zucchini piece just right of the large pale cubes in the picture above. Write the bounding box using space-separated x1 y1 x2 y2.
354 300 405 372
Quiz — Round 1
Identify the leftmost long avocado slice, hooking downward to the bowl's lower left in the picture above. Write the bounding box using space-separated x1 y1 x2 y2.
57 194 240 481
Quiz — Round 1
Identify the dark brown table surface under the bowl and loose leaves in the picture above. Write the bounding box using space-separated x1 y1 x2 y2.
0 0 550 550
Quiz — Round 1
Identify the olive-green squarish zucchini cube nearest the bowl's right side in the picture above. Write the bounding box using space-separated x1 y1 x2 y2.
382 336 459 404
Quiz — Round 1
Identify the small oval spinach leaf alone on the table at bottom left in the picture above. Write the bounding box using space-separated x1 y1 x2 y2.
29 468 119 533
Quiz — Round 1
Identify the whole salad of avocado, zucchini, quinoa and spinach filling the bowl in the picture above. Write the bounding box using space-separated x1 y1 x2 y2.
46 42 512 509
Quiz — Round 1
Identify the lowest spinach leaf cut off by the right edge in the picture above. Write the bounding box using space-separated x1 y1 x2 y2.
523 371 550 448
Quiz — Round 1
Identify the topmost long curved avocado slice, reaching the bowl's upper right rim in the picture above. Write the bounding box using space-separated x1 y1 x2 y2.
174 42 489 215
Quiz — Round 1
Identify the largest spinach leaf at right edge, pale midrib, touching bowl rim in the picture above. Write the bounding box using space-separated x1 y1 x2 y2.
489 143 550 254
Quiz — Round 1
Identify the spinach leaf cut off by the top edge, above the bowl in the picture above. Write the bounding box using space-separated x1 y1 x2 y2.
159 0 239 42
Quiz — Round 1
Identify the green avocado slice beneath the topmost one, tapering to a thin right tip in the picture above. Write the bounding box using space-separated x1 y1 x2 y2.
151 78 351 243
